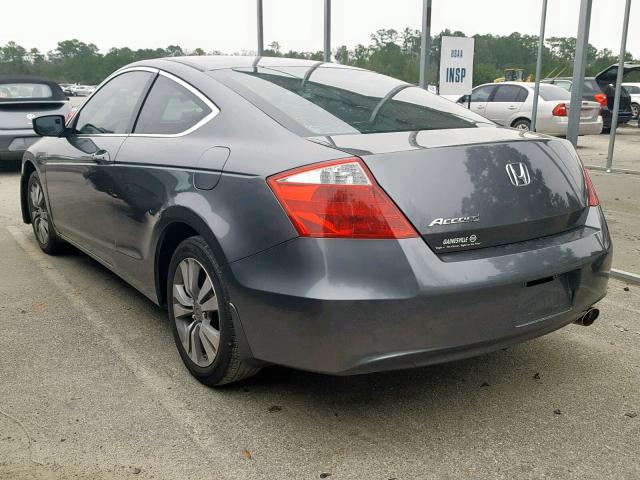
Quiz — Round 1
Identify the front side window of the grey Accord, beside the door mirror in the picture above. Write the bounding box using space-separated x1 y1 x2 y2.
75 71 154 135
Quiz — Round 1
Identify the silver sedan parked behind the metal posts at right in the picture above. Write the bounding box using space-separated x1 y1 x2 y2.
458 82 602 135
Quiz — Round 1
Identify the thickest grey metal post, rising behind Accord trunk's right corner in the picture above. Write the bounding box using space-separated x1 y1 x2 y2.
567 0 592 147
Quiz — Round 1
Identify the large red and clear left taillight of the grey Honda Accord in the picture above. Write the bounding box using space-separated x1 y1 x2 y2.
267 157 418 238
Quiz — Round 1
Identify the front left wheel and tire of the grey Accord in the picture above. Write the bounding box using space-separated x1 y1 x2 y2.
27 172 64 255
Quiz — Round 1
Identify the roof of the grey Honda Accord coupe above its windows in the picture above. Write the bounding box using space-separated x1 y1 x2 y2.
127 55 360 72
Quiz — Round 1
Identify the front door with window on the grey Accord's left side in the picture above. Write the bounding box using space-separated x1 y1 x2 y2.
45 70 156 264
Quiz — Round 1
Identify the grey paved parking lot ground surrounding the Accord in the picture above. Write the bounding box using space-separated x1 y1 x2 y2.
0 141 640 480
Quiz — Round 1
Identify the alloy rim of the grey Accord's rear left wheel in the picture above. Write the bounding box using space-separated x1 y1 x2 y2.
172 258 220 367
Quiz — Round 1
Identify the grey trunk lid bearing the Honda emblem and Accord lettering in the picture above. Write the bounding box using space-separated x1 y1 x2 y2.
314 128 587 253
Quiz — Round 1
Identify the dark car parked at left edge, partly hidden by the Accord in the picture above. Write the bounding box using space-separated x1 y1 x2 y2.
0 76 69 161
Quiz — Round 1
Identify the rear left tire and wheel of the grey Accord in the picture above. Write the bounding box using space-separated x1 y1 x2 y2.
167 236 261 386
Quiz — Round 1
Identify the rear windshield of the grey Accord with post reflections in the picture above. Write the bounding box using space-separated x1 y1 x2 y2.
219 66 488 135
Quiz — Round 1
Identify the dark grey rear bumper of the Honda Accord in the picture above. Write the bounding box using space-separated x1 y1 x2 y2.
230 208 611 374
